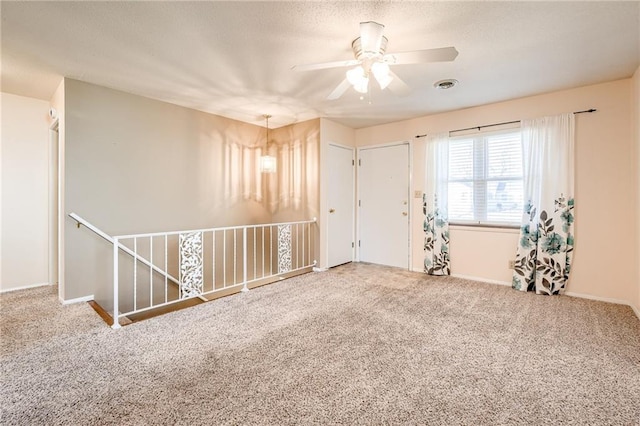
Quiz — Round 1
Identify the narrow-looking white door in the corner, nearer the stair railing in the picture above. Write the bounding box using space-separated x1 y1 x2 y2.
327 144 355 268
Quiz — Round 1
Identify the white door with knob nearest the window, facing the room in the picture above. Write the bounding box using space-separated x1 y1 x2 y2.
358 143 409 268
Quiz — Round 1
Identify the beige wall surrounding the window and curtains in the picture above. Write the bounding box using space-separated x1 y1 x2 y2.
356 79 638 303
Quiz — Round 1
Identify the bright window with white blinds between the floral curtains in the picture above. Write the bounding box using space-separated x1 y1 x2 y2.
448 130 524 225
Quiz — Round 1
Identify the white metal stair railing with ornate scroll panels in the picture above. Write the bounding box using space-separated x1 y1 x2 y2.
69 213 317 328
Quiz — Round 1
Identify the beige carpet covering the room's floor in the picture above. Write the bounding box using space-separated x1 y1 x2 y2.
0 264 640 425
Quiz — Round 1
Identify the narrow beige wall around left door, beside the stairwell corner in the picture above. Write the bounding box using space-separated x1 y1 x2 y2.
318 118 356 269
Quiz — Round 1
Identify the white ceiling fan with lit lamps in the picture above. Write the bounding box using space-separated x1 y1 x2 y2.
291 21 458 100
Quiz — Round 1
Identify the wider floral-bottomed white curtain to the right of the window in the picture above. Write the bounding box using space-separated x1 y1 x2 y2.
512 113 575 294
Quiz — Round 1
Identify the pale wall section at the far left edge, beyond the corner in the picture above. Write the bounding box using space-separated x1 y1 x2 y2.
0 93 50 291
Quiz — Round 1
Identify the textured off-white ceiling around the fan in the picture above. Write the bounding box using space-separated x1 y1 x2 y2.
0 1 640 128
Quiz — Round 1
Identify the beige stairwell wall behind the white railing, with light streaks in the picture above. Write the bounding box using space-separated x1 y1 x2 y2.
64 79 319 307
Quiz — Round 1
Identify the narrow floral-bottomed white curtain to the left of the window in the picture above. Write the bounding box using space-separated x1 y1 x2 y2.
422 133 451 275
